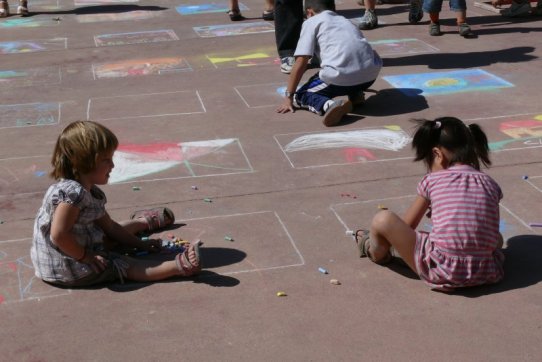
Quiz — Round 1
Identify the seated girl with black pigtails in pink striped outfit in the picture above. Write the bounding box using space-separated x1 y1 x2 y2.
355 117 504 291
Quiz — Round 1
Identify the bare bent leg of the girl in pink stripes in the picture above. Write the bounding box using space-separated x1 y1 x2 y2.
369 210 416 271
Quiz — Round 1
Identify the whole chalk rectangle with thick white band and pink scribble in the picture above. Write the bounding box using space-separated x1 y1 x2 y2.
275 125 411 168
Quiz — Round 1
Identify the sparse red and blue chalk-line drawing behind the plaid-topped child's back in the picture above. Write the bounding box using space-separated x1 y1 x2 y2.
0 243 71 304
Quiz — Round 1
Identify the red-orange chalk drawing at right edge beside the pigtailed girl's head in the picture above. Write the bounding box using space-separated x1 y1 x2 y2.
489 115 542 151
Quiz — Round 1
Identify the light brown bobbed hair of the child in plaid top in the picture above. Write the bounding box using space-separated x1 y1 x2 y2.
51 121 119 181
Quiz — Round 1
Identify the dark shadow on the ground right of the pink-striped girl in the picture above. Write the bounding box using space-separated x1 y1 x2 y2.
453 235 542 298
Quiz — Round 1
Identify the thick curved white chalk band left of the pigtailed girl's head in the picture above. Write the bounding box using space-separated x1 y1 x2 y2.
284 128 411 152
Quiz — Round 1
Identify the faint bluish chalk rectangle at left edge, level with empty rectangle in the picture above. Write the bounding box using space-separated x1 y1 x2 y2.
0 103 60 128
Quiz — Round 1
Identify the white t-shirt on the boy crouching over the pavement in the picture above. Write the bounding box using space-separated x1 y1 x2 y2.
294 10 382 86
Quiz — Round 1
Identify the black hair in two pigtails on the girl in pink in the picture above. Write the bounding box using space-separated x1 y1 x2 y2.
412 117 491 170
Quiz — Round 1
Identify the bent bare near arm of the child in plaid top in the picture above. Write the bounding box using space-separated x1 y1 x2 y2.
51 202 106 273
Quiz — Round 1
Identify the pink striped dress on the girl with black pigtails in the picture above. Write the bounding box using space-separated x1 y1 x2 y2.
415 165 504 291
